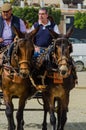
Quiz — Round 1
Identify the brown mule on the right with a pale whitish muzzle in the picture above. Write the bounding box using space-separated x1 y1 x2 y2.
33 25 75 130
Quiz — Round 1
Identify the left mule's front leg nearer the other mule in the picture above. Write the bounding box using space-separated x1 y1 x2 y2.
16 98 26 130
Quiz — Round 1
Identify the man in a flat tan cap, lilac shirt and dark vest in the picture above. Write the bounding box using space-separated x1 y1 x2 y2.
0 3 26 65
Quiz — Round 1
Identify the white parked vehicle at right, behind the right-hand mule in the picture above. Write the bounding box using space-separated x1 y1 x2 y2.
69 38 86 71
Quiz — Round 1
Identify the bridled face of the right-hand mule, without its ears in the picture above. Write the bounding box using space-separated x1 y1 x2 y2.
54 38 71 74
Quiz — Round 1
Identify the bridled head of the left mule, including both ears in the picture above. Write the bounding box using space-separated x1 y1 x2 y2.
11 27 38 78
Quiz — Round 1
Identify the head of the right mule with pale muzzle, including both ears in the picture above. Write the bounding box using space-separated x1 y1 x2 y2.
48 27 73 78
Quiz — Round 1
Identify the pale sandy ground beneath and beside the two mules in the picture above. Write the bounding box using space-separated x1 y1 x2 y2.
0 72 86 130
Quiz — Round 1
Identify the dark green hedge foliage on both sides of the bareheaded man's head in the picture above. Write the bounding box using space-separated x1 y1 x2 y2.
13 6 61 25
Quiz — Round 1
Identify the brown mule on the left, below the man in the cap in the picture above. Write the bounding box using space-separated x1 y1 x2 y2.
2 28 44 130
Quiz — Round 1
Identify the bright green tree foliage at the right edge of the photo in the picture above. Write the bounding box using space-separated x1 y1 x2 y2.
74 11 86 29
